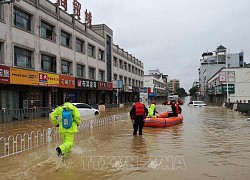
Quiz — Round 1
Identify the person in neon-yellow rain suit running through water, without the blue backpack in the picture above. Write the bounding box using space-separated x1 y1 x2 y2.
51 97 81 156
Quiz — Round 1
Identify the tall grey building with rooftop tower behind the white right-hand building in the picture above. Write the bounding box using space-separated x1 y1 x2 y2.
198 45 244 98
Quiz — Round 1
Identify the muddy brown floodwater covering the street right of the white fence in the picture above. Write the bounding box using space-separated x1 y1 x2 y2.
0 99 250 180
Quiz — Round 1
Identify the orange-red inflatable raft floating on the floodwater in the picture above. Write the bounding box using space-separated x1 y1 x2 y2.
144 112 183 127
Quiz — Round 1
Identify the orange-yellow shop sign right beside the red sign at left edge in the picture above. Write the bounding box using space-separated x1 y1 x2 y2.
10 68 38 85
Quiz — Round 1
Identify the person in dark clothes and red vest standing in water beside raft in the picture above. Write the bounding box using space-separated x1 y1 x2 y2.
130 98 148 135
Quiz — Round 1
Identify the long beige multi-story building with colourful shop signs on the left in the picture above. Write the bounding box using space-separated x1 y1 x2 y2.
0 0 144 109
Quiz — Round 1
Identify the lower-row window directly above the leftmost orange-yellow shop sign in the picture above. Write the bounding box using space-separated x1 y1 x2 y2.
14 47 32 68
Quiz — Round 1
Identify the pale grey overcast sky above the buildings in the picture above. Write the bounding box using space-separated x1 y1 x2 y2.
51 0 250 92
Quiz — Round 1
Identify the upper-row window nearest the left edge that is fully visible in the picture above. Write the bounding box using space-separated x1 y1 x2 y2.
14 8 31 31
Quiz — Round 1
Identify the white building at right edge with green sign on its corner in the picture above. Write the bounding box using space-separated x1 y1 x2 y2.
207 67 250 105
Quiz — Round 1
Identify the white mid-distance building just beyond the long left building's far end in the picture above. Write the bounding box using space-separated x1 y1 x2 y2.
144 69 168 100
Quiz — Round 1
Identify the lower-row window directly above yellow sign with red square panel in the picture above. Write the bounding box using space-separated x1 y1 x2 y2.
41 54 56 73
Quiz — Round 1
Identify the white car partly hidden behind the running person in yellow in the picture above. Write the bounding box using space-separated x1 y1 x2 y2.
49 103 100 116
